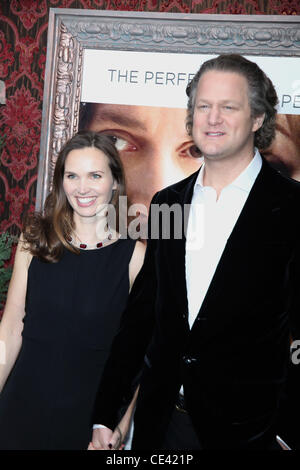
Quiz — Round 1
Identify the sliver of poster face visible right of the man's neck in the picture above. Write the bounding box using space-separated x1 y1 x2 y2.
262 114 300 181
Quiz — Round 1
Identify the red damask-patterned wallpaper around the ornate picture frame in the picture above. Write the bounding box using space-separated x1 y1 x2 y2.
0 0 300 234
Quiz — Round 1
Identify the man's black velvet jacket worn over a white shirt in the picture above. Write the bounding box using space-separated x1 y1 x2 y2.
94 161 300 449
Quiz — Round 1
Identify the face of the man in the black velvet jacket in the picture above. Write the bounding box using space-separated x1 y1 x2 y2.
193 70 260 160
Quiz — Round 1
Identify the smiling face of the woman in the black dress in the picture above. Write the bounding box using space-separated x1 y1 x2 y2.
63 147 117 221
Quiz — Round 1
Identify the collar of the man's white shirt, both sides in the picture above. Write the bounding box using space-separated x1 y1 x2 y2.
194 148 262 192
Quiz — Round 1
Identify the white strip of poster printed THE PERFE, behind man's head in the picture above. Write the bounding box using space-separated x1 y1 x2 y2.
81 49 300 114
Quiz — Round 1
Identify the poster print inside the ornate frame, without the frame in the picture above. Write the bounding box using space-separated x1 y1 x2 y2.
79 49 300 220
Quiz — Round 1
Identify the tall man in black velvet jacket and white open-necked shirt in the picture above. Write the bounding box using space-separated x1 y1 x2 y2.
93 55 300 449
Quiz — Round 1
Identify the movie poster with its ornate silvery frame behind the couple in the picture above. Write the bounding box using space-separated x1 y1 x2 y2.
37 9 300 221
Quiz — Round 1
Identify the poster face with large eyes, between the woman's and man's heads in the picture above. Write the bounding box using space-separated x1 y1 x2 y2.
88 104 201 216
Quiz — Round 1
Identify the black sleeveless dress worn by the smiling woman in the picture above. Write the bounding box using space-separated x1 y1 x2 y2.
0 239 135 450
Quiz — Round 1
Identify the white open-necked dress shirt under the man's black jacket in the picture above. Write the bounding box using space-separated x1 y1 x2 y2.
185 149 262 328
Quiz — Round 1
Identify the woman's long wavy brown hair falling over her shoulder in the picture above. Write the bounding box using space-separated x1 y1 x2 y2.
23 131 125 263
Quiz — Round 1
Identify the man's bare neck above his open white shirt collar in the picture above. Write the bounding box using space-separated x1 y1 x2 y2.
203 151 254 197
